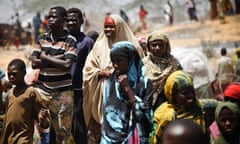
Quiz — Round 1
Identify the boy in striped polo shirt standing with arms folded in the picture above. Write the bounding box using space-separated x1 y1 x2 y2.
31 6 77 144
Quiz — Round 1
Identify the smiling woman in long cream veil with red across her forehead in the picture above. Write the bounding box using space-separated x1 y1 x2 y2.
83 15 143 141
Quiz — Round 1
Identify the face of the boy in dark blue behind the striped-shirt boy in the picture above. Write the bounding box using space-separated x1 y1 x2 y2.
67 13 81 34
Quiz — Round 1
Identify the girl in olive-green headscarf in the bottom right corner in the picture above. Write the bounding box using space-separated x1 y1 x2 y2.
210 102 240 144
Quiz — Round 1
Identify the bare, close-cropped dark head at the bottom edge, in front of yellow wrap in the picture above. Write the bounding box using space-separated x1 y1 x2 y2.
163 119 205 144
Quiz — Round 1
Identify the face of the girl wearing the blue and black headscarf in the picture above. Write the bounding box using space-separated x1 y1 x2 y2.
111 57 129 75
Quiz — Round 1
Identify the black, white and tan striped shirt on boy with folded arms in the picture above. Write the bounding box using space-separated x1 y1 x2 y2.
32 32 77 92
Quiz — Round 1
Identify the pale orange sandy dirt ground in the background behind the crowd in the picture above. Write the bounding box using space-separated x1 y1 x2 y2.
0 15 240 71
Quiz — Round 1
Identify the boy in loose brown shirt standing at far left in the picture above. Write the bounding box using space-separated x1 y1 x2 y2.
0 59 50 144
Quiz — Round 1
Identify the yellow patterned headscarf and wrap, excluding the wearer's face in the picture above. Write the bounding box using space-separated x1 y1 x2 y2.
150 70 205 144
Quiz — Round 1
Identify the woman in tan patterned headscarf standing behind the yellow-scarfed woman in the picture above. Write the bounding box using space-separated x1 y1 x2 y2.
143 31 181 109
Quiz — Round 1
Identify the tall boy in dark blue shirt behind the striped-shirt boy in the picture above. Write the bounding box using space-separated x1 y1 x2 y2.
67 8 94 144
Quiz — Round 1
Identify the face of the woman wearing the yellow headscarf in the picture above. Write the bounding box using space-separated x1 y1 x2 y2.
176 86 195 108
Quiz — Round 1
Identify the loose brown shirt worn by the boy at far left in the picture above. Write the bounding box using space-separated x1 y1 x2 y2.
0 87 45 144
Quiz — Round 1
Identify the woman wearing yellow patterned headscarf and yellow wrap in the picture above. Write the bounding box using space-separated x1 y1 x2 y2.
149 70 216 144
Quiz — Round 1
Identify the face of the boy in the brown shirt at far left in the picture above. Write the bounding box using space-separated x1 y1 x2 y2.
7 65 25 85
